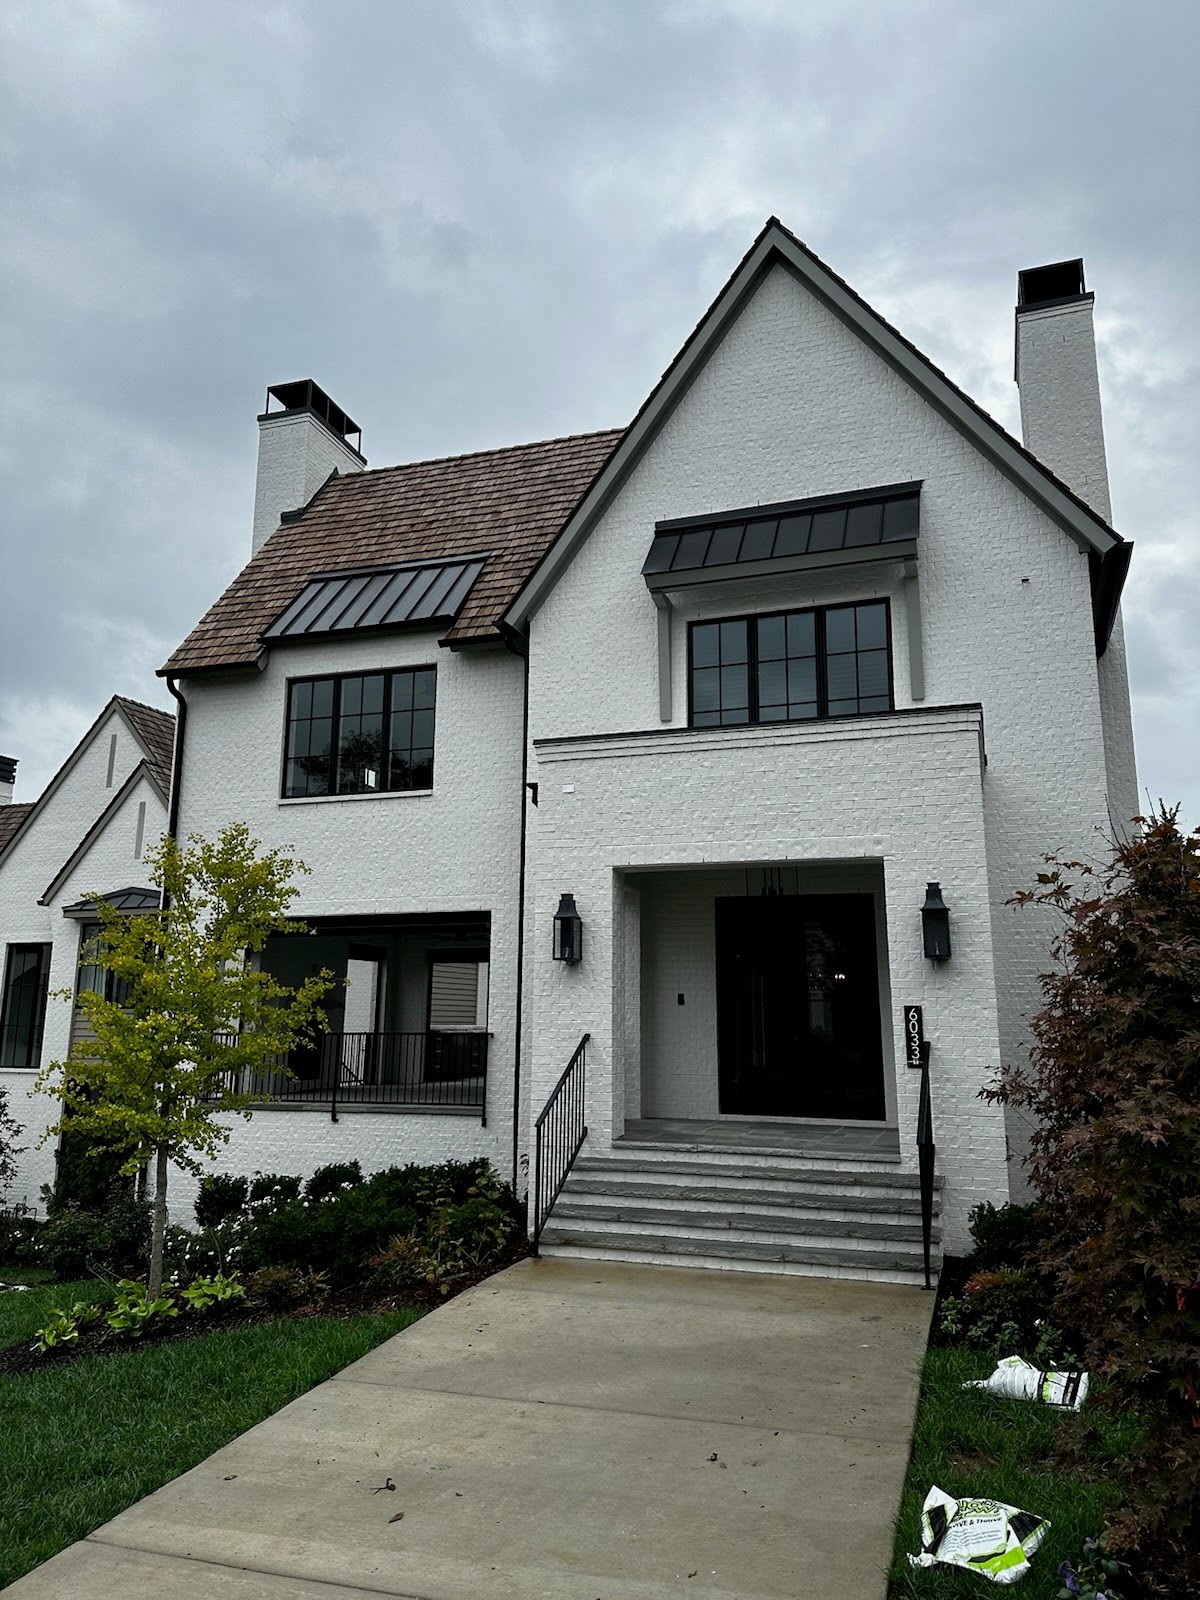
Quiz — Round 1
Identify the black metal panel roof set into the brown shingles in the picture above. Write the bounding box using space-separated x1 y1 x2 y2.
262 555 485 638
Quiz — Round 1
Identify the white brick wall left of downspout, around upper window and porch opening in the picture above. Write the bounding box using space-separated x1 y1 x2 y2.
179 630 523 1196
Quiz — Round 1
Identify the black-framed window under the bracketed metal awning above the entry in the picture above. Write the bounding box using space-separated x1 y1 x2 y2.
688 600 893 728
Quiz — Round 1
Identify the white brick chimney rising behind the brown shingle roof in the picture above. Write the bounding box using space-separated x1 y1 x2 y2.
250 378 366 555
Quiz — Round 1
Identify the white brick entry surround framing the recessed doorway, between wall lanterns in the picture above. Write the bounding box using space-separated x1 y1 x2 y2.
526 710 1006 1248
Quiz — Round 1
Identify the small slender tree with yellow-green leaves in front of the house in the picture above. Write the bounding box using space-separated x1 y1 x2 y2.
37 822 333 1298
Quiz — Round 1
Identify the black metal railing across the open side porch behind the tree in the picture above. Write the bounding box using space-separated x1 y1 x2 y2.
209 1029 488 1125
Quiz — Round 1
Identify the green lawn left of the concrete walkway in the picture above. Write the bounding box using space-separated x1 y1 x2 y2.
0 1283 421 1589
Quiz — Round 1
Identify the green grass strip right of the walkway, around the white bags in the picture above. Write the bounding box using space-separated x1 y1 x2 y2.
888 1347 1136 1600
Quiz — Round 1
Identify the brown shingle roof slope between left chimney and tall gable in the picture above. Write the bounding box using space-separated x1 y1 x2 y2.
160 429 622 674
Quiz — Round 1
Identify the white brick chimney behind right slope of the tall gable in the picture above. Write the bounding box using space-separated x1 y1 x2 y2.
1014 261 1112 522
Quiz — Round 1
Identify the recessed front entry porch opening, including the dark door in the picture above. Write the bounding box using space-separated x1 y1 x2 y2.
633 861 898 1155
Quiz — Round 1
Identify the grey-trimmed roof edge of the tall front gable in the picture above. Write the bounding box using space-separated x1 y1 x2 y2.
506 218 1133 653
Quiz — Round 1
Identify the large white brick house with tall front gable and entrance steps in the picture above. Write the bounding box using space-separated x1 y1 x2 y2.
0 219 1136 1278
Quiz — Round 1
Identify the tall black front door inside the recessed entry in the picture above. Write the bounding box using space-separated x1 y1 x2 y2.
717 894 885 1122
